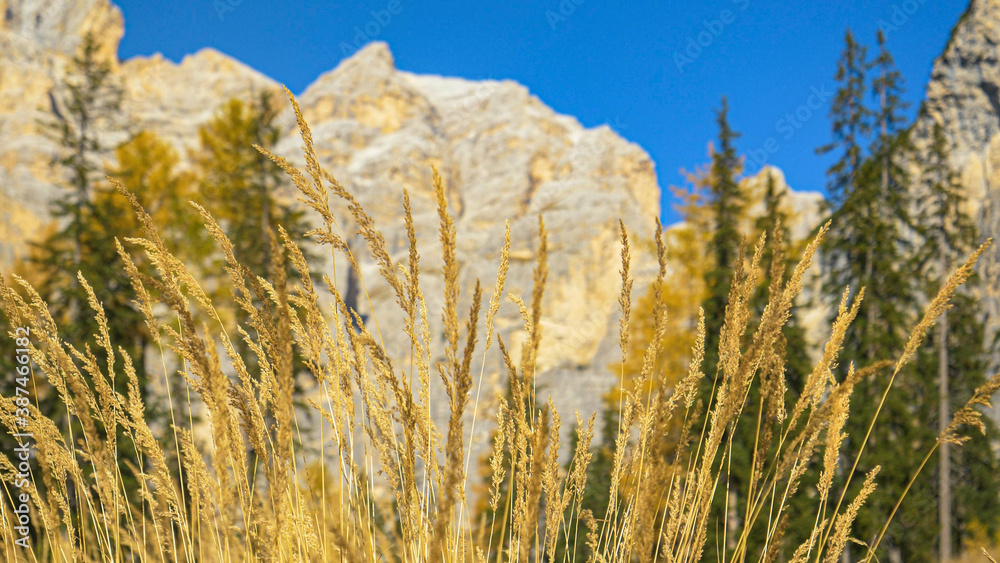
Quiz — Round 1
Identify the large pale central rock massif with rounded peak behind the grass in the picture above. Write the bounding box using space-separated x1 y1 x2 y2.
277 43 660 454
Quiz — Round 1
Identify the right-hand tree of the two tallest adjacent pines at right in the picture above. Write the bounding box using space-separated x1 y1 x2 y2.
860 32 934 560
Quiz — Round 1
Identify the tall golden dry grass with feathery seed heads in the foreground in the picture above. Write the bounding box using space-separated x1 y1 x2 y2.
0 90 1000 563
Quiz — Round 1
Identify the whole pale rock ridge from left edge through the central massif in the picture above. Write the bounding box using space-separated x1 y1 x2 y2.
0 0 672 460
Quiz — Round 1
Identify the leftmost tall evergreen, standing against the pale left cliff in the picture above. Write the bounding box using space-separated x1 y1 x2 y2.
30 35 147 418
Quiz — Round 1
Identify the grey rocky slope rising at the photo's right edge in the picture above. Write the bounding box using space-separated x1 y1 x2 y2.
914 0 1000 367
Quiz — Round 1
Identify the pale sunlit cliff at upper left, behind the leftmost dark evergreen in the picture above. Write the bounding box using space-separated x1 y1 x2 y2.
0 0 278 265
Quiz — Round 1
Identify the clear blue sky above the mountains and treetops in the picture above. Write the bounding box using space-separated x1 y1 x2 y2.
117 0 968 225
